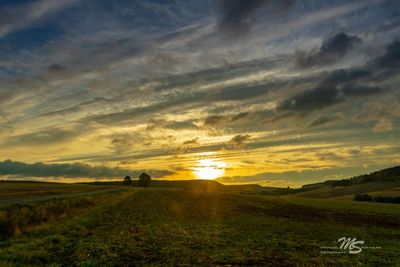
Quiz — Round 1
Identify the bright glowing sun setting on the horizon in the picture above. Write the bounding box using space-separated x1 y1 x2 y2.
193 159 227 180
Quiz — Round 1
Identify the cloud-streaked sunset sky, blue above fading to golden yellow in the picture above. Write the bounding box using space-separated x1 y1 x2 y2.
0 0 400 187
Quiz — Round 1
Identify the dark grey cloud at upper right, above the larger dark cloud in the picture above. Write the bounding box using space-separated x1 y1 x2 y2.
294 32 361 67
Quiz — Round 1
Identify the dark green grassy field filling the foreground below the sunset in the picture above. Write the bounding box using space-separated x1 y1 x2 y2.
0 188 400 266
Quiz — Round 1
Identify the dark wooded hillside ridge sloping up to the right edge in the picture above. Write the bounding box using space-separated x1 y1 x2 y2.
303 166 400 188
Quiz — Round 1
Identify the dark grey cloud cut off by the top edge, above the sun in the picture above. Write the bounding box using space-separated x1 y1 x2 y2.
218 0 295 34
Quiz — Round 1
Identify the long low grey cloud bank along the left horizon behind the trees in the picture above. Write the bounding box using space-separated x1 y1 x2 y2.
0 160 172 179
